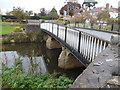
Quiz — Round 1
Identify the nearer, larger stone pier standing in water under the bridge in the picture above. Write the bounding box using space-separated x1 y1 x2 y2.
58 48 83 69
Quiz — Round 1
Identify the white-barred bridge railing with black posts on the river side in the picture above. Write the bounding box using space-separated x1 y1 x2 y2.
41 23 108 67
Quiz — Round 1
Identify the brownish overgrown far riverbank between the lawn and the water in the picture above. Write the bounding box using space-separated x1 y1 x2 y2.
0 31 43 44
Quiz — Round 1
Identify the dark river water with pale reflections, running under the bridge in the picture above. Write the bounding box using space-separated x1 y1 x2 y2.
0 43 85 79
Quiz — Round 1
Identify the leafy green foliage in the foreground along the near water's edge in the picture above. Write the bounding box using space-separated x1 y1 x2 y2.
2 59 73 89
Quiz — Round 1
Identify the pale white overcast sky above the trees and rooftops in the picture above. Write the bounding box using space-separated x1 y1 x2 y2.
0 0 120 14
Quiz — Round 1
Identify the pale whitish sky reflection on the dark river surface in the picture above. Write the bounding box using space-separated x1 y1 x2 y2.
0 51 48 75
